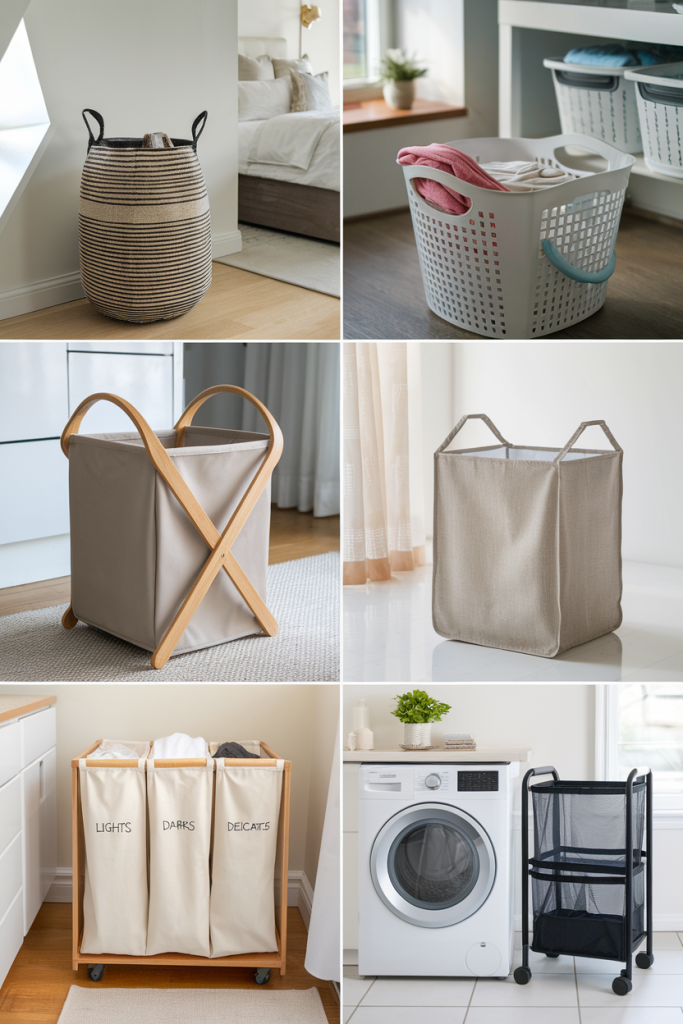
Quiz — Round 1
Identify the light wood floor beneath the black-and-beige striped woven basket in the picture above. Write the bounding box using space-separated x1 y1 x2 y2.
0 263 341 341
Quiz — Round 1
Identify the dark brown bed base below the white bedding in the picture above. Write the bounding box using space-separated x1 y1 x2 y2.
238 174 341 242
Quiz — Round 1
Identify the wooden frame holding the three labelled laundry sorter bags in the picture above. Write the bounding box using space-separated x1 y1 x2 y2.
71 739 292 975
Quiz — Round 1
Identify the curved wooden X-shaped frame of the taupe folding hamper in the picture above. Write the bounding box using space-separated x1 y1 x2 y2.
61 384 283 669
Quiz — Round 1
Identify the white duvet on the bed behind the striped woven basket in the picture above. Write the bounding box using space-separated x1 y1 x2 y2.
240 111 340 191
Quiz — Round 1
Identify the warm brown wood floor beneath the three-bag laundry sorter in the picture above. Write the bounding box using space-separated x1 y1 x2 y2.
0 903 339 1024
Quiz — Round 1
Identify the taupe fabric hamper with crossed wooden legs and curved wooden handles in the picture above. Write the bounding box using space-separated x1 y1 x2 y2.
61 384 283 669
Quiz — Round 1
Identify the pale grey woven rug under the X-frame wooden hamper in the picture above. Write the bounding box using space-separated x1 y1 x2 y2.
0 551 340 683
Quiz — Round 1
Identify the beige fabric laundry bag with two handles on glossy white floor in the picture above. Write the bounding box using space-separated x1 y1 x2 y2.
432 414 623 657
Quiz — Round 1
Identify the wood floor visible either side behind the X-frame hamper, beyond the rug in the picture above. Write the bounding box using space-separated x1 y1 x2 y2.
0 505 339 615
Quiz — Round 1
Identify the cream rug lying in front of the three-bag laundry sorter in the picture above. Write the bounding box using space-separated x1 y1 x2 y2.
57 983 327 1024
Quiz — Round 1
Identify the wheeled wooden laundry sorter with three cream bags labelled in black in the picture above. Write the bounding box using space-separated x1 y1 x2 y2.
72 740 292 985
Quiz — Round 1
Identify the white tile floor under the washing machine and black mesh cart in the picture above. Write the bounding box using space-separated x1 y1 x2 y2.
342 932 683 1024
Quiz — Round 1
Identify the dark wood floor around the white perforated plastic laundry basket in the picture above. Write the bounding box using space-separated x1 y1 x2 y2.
344 211 683 341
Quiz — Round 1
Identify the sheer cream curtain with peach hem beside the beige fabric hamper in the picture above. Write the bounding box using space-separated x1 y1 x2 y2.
344 341 425 585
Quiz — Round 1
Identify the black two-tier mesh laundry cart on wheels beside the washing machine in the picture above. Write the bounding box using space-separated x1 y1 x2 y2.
514 767 654 995
